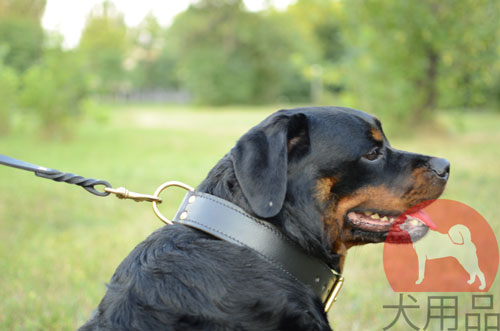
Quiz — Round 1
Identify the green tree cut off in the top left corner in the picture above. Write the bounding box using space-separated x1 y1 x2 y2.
0 0 46 71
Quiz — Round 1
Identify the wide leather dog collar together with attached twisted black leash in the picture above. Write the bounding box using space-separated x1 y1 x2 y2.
0 154 344 312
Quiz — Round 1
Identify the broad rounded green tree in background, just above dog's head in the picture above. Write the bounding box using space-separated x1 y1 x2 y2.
166 0 310 104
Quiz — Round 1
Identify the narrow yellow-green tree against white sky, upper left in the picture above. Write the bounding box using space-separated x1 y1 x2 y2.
78 1 128 93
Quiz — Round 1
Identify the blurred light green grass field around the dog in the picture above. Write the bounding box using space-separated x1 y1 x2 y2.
0 106 500 330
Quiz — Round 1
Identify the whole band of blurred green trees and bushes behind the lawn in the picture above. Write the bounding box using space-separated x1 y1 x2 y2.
0 0 500 137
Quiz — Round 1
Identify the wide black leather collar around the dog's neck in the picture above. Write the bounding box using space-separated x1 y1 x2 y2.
173 191 344 312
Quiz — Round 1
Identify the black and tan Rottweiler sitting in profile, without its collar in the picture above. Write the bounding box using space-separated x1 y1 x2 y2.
81 107 449 331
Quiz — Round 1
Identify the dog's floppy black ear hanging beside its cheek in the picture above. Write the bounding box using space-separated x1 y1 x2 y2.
231 113 309 218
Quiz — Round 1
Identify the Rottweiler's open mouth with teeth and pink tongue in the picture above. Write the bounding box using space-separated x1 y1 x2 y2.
346 209 437 236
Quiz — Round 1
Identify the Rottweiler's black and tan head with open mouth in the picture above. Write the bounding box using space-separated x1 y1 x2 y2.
217 107 449 266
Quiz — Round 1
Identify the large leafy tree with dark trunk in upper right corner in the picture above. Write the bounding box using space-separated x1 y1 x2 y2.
343 0 500 125
